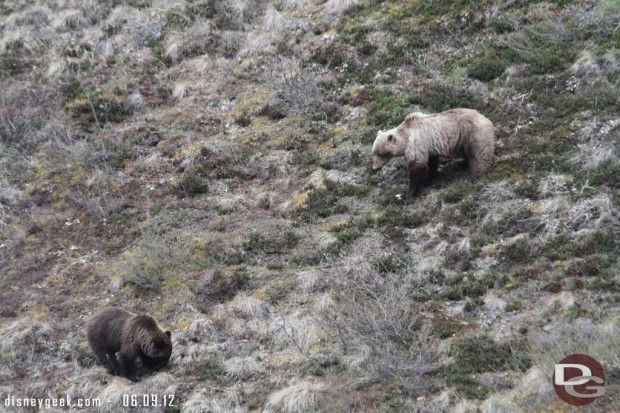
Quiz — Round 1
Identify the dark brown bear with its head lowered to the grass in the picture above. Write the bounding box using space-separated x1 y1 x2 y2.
86 307 172 381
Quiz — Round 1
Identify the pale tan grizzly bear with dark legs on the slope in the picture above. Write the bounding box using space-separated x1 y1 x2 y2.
372 109 495 200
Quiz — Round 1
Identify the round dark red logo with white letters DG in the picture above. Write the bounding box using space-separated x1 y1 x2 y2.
553 354 605 406
